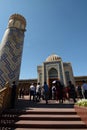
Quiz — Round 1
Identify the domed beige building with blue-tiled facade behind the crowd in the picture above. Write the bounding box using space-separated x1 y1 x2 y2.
37 54 75 87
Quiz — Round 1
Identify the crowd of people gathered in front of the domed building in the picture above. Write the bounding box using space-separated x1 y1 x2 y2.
20 80 87 104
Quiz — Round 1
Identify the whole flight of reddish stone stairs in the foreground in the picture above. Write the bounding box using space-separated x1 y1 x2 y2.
0 107 87 130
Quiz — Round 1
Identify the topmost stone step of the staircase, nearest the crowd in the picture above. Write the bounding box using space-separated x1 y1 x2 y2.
3 108 77 115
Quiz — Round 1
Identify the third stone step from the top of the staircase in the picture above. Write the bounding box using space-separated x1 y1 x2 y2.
2 120 87 129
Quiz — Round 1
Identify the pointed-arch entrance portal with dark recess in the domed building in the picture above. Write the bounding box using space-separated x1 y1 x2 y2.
48 68 58 87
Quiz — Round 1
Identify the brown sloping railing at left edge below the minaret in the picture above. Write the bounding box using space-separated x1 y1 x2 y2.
0 83 11 113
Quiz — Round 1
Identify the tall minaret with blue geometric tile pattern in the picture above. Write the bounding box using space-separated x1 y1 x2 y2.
0 14 26 88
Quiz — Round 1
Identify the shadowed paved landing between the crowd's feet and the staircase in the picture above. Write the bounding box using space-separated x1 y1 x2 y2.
15 96 74 109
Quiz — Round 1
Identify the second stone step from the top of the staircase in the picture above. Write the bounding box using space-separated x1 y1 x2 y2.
2 114 81 121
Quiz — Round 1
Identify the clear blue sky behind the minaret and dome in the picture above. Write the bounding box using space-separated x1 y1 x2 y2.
0 0 87 79
